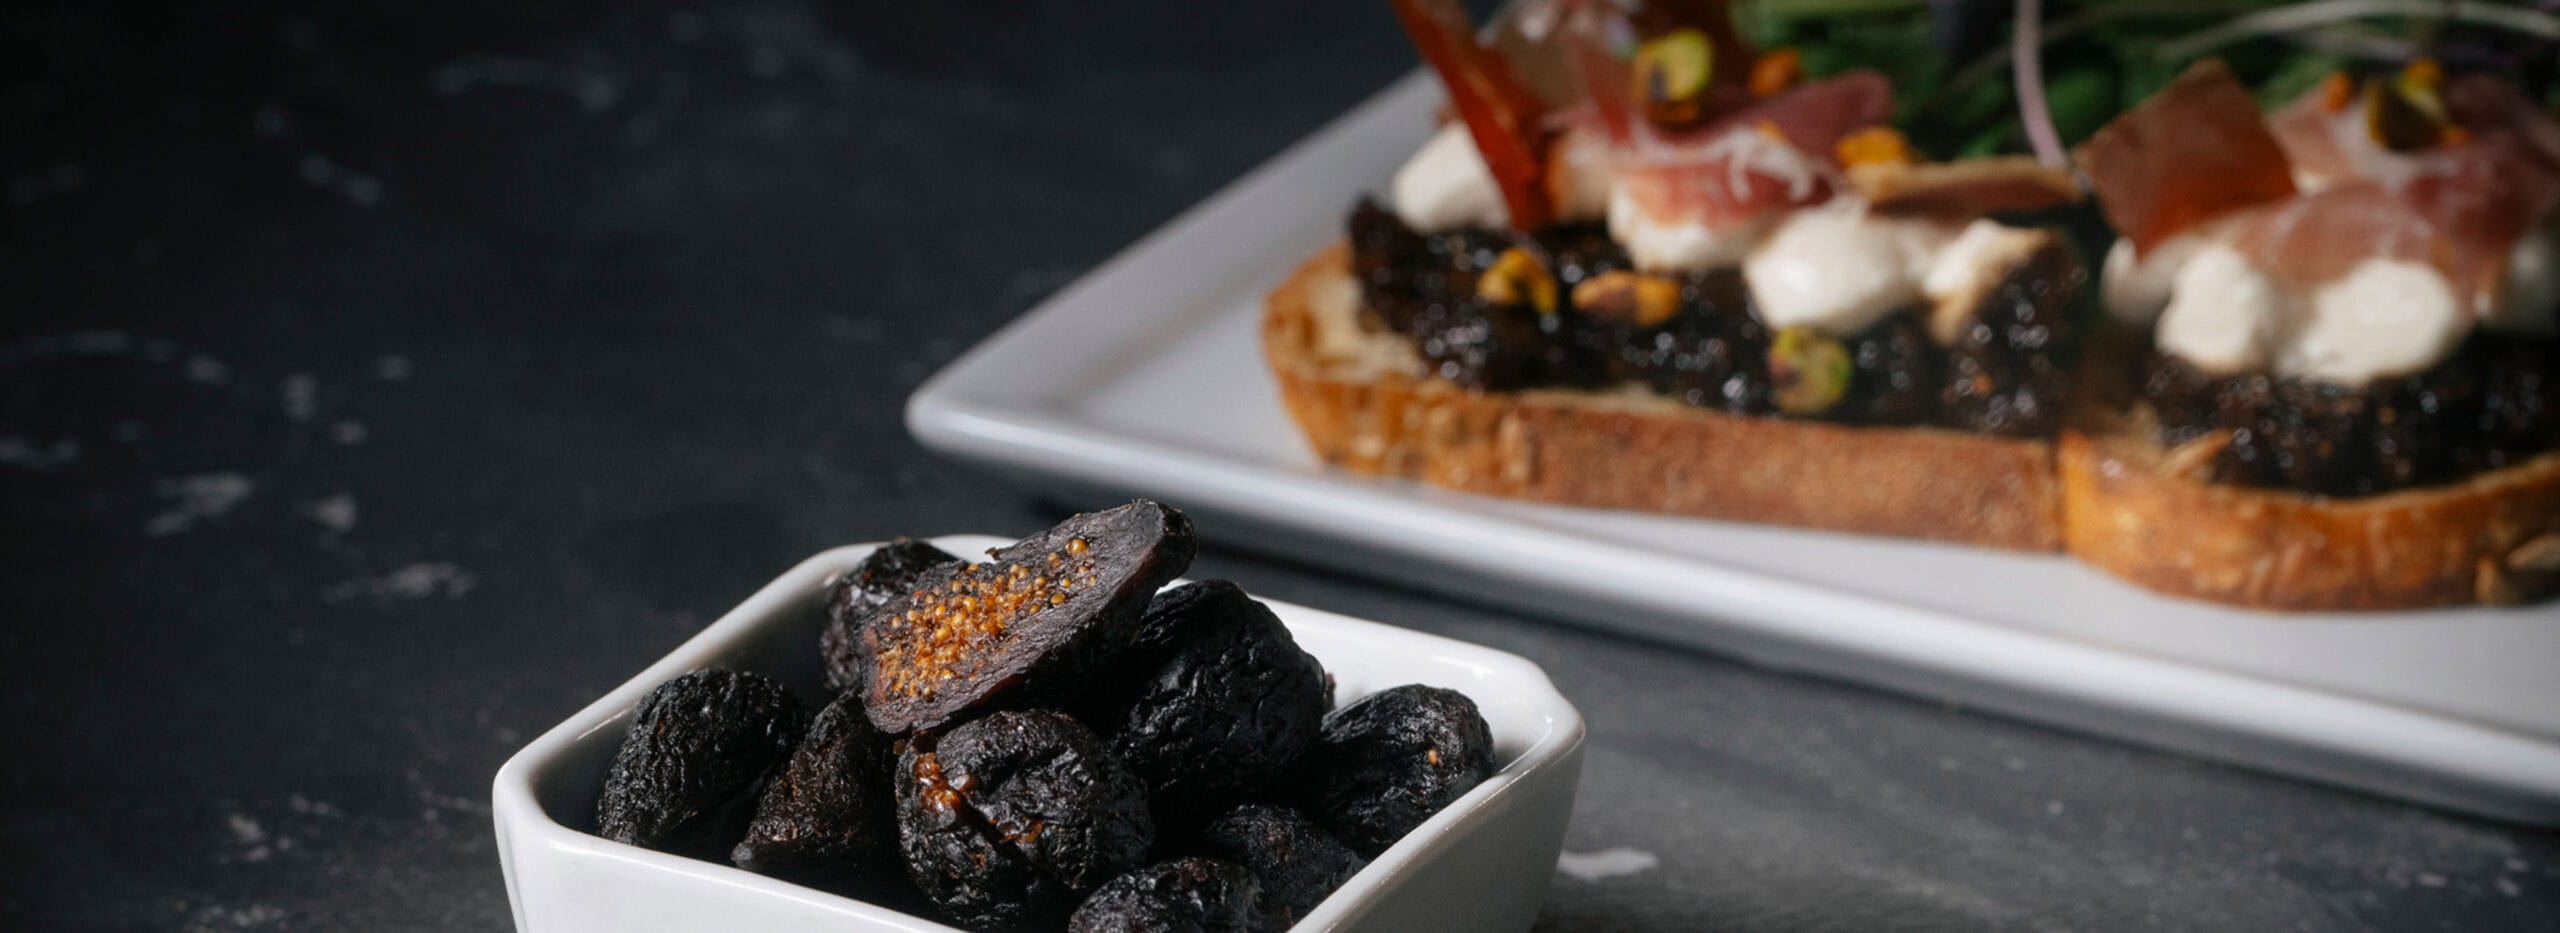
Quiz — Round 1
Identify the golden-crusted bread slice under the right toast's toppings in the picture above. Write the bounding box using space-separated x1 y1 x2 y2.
2061 405 2560 610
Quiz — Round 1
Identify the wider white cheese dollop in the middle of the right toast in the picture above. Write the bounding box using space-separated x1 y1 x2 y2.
2283 256 2470 384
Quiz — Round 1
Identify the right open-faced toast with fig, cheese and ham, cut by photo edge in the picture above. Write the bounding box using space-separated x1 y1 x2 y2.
2061 59 2560 607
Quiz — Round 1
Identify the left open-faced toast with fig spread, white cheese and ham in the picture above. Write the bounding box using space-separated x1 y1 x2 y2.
1262 0 2086 551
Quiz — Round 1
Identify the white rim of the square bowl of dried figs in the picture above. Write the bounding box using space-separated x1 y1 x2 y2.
489 533 1587 933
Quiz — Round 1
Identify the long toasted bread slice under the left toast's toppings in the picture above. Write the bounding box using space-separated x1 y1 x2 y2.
1262 244 2061 551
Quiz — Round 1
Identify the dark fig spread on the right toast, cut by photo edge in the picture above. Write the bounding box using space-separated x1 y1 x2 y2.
2143 333 2560 497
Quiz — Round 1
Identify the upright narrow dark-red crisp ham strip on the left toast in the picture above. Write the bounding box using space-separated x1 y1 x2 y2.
1395 0 1554 231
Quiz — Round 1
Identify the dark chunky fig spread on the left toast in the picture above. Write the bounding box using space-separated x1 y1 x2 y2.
1349 200 2084 436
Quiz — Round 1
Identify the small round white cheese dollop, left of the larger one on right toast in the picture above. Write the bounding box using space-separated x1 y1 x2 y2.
2153 244 2286 374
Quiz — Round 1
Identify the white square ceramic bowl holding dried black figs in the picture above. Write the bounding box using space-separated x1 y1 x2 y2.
492 536 1582 933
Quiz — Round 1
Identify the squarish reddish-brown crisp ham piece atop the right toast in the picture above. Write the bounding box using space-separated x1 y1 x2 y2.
2076 62 2294 251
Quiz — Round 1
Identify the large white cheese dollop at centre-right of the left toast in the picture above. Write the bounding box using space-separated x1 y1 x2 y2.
1743 197 1953 336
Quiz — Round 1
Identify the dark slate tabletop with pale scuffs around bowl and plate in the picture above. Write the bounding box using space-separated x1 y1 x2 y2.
0 3 2560 930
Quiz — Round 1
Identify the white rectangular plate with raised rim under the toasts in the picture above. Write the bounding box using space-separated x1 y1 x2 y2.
906 74 2560 825
